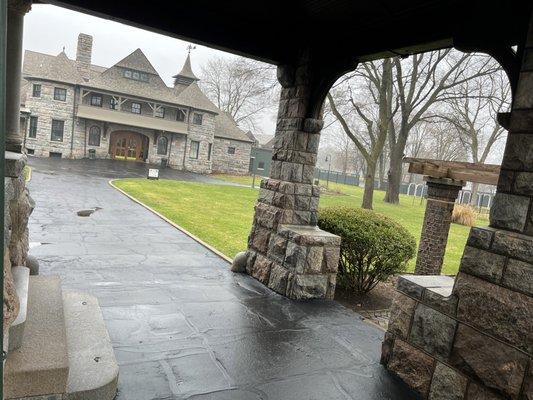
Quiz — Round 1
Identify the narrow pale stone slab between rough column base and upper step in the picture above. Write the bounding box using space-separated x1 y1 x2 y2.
9 267 30 351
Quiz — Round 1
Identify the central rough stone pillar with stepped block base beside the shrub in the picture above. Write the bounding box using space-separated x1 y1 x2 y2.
241 59 340 299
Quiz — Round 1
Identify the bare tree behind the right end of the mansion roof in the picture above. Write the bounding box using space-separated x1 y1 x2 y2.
200 57 277 130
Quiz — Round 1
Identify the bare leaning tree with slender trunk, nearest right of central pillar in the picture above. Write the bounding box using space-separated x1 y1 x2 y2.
328 59 394 209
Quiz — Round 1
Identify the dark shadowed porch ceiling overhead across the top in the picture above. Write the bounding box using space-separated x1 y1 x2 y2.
44 0 532 64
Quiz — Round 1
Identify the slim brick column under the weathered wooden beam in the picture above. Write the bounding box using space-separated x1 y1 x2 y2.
415 177 464 275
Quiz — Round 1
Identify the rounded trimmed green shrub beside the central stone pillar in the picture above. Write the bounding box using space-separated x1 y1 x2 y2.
318 207 416 293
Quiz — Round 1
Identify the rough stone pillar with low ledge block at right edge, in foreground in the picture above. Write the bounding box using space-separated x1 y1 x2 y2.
382 10 533 400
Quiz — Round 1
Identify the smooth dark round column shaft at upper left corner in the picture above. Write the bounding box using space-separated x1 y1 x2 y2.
6 0 31 153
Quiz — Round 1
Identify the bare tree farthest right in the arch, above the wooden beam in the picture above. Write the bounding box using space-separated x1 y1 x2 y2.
440 71 511 204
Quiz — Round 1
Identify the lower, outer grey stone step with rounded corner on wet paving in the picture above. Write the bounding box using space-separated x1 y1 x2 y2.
63 291 118 400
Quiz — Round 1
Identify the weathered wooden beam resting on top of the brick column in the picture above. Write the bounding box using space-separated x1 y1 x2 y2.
403 157 500 185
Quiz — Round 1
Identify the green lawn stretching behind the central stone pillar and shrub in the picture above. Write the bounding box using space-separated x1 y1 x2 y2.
114 177 487 274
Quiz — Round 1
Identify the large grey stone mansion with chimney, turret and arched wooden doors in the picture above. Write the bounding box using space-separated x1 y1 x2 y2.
21 33 252 174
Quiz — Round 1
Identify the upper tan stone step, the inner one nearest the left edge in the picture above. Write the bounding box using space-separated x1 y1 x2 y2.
4 276 69 399
